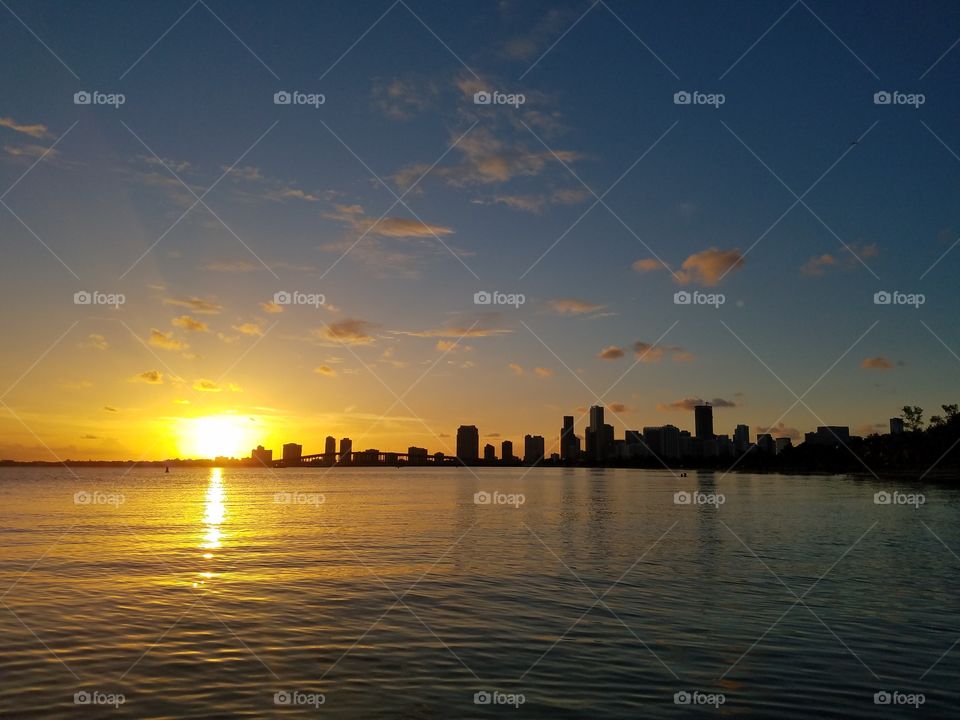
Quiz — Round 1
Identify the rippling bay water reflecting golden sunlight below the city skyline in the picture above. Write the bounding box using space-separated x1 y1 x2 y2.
0 468 960 719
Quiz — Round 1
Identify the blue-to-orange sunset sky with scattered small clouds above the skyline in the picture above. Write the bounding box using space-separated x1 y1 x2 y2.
0 0 960 460
